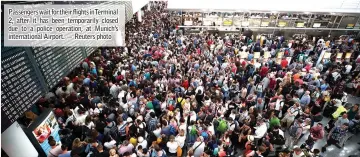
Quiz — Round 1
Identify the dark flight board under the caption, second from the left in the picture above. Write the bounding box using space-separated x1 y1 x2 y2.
33 47 83 89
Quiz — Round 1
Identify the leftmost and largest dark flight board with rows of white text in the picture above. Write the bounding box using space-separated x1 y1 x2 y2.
1 47 45 132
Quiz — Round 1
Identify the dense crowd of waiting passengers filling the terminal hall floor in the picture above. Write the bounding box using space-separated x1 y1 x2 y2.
24 2 360 157
